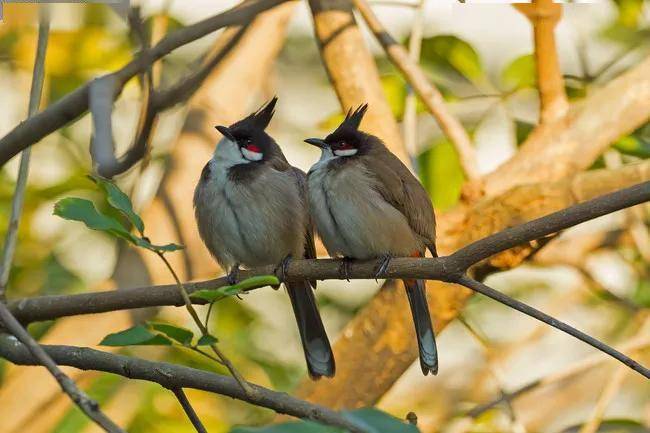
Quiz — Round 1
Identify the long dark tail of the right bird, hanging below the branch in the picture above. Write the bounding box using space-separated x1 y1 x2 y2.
403 280 438 376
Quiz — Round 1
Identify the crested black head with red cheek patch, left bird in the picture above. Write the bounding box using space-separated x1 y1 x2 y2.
215 96 278 161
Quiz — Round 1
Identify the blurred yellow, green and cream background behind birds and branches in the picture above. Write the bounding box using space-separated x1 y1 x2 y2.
0 0 650 433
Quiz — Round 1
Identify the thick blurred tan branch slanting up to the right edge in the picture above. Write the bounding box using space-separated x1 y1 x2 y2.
483 57 650 196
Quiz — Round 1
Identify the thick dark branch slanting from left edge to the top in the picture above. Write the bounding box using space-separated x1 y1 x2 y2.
0 0 287 165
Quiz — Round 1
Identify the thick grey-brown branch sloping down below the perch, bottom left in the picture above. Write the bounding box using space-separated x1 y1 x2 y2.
0 336 363 432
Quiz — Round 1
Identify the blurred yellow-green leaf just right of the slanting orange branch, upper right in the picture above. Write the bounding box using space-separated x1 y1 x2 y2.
420 35 484 82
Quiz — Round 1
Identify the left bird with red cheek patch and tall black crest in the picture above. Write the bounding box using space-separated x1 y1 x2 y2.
194 97 335 380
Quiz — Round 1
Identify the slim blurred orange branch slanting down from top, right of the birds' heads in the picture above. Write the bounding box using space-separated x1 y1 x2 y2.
353 0 479 180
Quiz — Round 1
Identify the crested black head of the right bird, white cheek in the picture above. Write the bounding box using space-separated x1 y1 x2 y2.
305 104 368 156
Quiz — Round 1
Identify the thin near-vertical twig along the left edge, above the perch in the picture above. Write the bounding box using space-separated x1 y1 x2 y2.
0 6 50 302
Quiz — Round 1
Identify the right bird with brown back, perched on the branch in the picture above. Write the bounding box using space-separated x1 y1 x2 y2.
305 104 438 376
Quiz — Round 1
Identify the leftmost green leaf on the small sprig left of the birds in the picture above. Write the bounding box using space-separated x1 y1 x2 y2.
54 197 138 244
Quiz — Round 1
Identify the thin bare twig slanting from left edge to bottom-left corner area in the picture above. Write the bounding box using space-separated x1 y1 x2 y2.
0 302 126 433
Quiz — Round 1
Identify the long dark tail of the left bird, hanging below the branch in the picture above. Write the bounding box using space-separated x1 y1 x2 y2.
286 281 336 379
